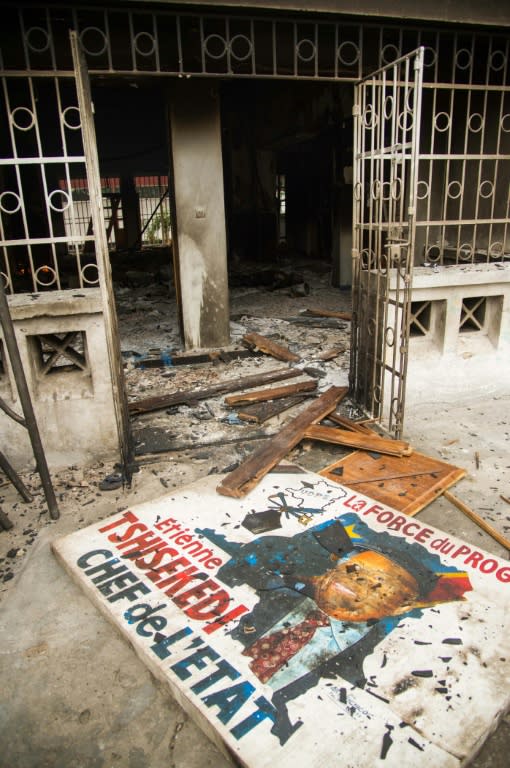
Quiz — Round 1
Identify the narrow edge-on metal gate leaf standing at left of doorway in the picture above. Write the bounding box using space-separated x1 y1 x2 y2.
69 30 133 483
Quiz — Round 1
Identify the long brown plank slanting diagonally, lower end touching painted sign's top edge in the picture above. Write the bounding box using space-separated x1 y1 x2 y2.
216 387 349 499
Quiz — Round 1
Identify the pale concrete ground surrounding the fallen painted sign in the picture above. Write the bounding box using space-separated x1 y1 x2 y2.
0 268 510 768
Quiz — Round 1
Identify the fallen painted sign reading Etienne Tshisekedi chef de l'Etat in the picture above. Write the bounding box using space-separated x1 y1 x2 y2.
53 470 510 768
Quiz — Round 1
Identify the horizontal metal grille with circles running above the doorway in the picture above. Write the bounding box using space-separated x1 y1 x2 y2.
0 4 510 88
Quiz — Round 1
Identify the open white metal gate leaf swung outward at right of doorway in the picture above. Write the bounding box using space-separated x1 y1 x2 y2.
350 48 423 438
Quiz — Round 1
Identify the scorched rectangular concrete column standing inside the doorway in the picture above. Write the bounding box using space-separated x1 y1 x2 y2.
170 80 230 350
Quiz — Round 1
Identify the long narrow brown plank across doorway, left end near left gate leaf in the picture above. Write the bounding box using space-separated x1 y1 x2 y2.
129 368 301 414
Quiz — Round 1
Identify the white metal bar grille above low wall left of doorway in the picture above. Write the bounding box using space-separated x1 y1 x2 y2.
0 77 98 292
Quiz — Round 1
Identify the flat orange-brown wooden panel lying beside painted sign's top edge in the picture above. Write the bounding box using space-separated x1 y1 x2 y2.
319 451 466 515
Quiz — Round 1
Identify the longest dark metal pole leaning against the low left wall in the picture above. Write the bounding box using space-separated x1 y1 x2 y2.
0 280 60 520
